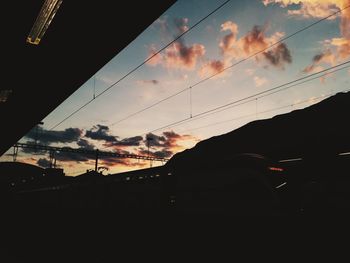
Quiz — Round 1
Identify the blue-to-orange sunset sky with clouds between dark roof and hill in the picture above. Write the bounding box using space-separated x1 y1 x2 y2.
0 0 350 176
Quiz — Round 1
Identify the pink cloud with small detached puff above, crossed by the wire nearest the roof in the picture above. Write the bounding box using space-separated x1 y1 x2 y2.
147 18 205 70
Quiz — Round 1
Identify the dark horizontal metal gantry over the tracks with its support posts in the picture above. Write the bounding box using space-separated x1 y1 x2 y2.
13 143 169 171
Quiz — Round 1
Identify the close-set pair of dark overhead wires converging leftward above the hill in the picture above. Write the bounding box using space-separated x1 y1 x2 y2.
144 60 350 134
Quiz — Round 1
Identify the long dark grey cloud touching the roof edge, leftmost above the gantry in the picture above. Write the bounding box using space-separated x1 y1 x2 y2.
24 127 82 144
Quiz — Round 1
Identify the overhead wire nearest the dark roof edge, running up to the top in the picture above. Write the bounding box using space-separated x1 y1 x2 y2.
50 0 231 130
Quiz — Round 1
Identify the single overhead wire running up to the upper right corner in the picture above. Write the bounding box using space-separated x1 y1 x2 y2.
111 3 350 126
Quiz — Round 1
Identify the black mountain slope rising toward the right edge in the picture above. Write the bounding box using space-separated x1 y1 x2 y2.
167 92 350 170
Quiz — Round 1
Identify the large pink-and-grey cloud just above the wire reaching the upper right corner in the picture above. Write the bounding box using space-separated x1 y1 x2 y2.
219 21 292 69
